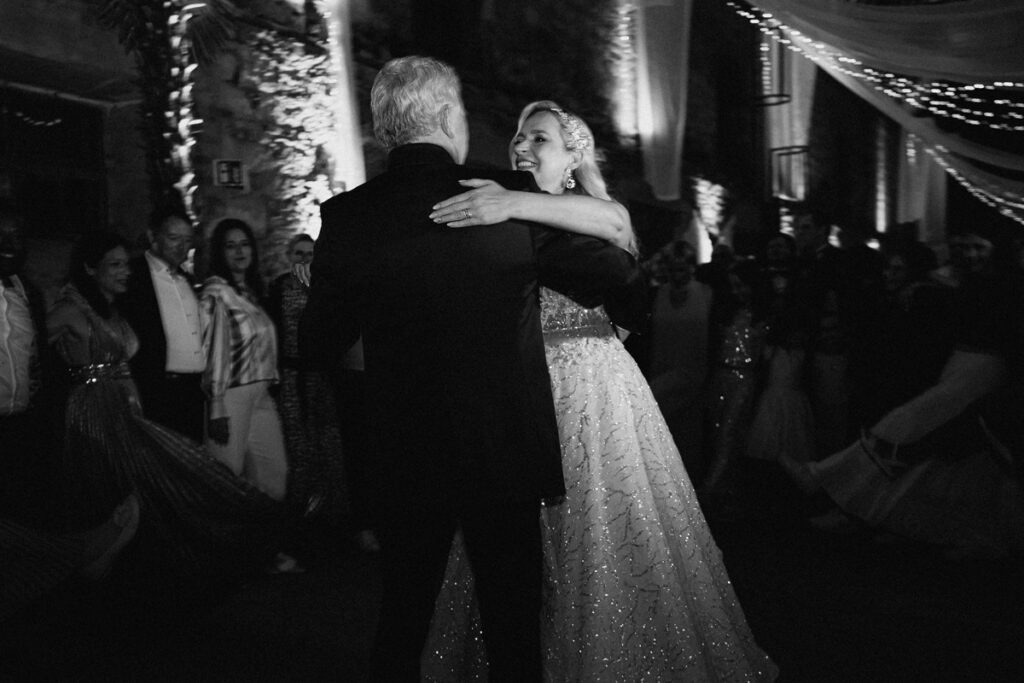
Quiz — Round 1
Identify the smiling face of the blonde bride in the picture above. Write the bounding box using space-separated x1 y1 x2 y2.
509 112 574 195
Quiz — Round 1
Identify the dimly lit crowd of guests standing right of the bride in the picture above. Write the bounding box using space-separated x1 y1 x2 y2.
632 209 1024 555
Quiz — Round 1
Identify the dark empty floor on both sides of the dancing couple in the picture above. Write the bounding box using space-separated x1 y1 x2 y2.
0 471 1024 683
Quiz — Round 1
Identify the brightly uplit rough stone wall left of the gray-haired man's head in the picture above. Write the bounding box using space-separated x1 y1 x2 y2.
193 0 337 279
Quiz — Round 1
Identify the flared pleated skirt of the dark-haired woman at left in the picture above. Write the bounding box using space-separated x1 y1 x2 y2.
63 366 285 575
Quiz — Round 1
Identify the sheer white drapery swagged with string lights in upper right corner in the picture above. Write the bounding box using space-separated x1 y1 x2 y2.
752 0 1024 229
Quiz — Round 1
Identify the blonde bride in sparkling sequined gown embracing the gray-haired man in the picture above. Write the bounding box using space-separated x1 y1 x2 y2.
422 102 777 683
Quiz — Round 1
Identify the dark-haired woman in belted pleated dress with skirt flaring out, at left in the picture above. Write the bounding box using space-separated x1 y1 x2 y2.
47 232 281 575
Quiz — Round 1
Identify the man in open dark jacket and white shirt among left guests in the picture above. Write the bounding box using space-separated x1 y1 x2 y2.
118 209 206 442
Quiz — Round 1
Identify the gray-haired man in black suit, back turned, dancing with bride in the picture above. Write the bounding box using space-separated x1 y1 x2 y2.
303 57 636 683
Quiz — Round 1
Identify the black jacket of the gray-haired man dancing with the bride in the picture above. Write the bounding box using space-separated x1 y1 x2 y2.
302 143 637 504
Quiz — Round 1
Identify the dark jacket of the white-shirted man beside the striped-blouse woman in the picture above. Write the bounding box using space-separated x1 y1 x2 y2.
117 254 179 405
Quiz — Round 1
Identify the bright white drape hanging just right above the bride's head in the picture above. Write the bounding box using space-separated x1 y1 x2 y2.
633 0 693 201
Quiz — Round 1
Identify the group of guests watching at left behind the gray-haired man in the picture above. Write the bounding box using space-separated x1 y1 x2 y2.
0 194 376 617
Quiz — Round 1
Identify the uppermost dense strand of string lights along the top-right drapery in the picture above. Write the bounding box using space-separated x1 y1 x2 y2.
726 0 1024 132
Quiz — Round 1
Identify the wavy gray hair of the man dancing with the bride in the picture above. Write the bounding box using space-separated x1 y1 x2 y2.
370 56 462 151
